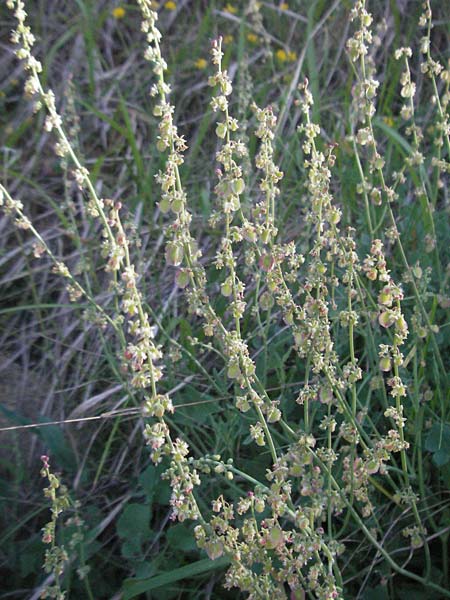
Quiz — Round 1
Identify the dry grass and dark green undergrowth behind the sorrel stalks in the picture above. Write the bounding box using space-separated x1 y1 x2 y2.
0 0 450 600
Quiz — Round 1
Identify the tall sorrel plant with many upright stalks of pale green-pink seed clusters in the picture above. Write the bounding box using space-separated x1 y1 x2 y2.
0 0 450 599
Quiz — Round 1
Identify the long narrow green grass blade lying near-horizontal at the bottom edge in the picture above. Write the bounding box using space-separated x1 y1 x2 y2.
122 557 230 600
